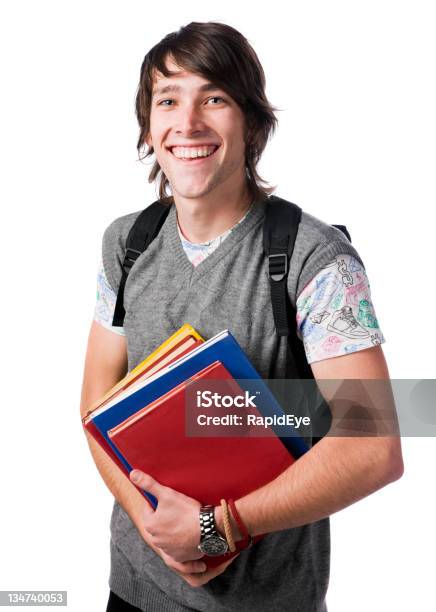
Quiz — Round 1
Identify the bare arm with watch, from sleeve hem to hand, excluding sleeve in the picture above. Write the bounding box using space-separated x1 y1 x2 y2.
131 346 403 559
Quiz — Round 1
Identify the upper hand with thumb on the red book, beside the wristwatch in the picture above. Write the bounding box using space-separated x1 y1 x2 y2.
130 470 204 564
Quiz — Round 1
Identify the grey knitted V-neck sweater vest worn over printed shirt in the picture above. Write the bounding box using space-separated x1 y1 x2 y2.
102 200 363 612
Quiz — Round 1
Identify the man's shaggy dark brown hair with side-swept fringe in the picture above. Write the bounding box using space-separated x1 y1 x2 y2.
136 21 278 200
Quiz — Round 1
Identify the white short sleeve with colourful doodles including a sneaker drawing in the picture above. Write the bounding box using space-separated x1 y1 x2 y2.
296 254 385 363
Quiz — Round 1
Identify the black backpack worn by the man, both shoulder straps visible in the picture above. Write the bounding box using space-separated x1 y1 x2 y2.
112 196 351 444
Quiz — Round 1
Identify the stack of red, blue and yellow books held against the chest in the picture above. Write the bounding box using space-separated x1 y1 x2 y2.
82 324 308 567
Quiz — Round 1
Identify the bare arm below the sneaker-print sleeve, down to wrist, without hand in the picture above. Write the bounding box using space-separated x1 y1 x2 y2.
225 346 403 535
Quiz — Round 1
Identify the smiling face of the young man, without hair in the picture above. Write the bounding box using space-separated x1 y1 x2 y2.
146 59 246 199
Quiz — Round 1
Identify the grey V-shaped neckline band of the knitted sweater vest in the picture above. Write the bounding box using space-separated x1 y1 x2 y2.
165 198 266 284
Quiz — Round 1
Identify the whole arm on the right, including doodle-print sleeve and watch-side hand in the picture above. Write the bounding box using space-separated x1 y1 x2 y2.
125 255 403 559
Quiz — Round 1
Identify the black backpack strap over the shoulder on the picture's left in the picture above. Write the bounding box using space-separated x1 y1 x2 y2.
112 200 171 327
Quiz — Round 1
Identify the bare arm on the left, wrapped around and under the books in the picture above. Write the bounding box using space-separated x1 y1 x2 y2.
80 321 208 575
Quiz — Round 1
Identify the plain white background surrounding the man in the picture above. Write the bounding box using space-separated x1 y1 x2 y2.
0 0 436 612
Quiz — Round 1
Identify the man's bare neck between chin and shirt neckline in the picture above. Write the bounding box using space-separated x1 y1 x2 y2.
170 179 253 243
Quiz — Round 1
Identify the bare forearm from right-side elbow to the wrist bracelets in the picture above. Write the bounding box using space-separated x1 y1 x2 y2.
236 437 402 536
